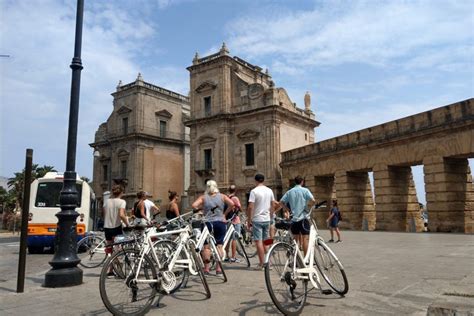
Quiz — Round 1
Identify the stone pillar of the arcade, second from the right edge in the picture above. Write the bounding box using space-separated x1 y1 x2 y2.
374 165 420 231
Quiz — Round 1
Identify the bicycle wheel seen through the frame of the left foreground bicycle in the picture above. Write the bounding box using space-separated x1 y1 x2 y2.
153 239 189 295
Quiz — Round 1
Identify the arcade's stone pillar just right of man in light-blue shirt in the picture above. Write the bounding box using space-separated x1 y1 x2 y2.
312 175 336 227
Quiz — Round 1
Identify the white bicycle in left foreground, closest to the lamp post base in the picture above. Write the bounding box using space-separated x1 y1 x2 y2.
99 212 211 315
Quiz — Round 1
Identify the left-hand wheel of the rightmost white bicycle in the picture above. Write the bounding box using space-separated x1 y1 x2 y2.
265 243 308 316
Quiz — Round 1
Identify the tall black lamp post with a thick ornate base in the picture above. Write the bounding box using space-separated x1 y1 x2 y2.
44 0 84 287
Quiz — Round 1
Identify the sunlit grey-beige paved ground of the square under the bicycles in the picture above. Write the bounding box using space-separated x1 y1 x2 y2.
0 231 474 316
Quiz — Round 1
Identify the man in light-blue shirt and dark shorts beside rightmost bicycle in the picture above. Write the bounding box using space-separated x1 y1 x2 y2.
280 176 315 253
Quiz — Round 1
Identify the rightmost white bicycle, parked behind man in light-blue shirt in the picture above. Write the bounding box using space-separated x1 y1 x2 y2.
264 203 349 315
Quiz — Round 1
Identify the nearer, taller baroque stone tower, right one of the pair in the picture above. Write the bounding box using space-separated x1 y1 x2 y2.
185 44 319 202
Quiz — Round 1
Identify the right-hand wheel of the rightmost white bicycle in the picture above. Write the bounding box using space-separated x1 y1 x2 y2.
314 239 349 296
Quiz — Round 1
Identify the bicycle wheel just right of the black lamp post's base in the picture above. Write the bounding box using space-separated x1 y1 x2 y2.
77 235 107 268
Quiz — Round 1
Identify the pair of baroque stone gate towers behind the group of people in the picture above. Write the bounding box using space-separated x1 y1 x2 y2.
90 44 319 207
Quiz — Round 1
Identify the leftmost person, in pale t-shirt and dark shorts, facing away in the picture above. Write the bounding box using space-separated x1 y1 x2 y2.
104 185 129 275
